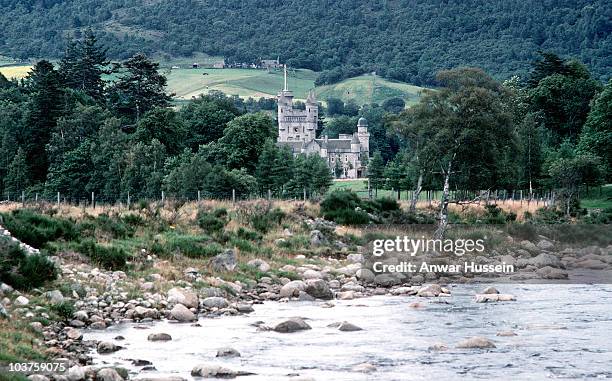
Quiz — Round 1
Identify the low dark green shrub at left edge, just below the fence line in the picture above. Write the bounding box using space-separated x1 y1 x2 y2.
2 209 79 248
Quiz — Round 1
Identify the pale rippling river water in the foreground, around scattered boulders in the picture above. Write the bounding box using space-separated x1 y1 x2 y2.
85 284 612 381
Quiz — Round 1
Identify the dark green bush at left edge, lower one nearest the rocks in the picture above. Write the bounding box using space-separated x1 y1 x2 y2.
0 238 57 290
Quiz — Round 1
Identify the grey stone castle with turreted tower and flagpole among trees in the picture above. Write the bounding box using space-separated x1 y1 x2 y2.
277 67 370 179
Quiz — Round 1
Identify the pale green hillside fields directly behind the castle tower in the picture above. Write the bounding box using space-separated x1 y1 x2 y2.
166 68 423 105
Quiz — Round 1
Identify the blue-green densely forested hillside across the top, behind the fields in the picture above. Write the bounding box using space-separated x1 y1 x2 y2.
0 0 612 84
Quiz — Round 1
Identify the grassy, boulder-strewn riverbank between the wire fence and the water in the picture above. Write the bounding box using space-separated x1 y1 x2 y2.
0 202 612 381
